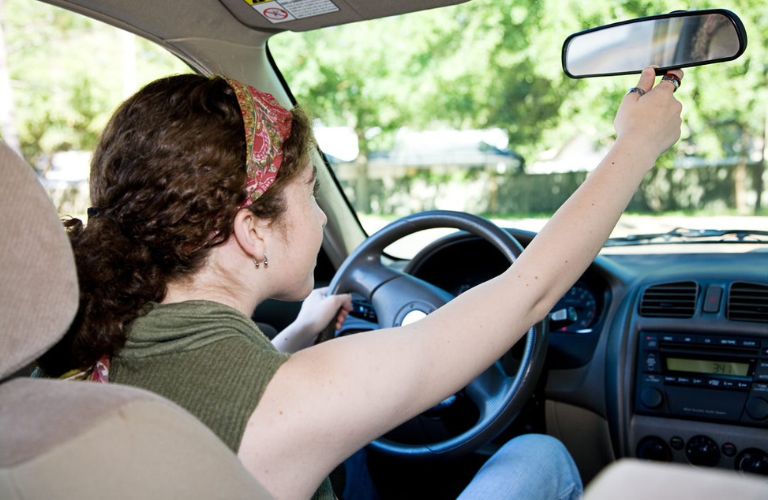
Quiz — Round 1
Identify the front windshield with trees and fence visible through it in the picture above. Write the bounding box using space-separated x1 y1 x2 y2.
269 0 768 257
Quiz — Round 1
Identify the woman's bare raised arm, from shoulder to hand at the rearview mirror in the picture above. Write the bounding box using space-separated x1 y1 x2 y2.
239 69 682 498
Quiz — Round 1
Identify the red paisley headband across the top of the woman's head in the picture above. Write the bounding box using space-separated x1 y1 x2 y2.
225 78 292 208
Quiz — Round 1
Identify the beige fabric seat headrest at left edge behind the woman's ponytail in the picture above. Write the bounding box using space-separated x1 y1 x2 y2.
0 141 78 379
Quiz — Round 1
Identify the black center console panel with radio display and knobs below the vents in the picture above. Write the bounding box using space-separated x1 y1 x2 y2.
630 331 768 475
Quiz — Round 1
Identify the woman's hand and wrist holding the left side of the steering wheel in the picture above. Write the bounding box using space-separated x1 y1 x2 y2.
272 287 352 352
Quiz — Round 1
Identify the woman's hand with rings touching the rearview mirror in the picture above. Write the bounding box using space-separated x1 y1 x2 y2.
614 67 683 160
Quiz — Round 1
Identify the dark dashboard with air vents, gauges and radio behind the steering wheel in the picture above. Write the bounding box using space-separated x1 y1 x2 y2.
396 230 768 481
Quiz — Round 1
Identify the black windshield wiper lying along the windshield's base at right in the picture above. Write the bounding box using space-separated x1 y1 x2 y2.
605 227 768 247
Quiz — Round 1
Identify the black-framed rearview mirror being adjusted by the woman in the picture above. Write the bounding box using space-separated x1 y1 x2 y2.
563 9 747 78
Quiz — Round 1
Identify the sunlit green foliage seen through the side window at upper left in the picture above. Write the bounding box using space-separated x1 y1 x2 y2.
0 0 187 168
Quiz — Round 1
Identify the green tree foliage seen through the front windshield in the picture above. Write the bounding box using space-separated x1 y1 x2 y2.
270 0 768 172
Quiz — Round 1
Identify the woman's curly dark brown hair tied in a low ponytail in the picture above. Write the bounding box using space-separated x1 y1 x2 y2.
40 74 312 375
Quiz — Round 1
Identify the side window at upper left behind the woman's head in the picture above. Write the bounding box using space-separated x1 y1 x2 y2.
0 0 190 218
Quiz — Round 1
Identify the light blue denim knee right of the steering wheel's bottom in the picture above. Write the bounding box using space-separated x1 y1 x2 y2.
459 434 583 500
